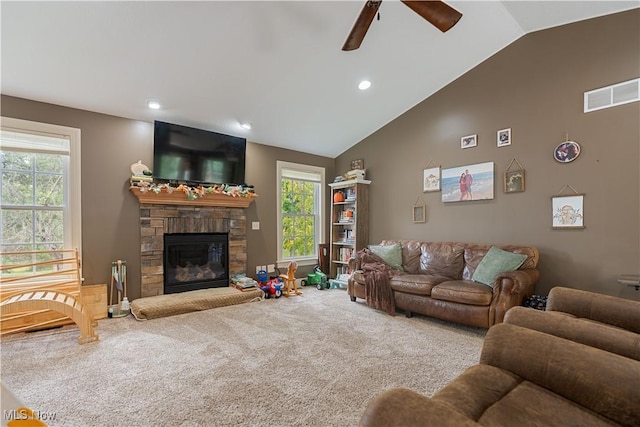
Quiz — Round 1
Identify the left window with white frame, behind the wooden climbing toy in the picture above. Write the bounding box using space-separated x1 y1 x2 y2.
0 117 81 253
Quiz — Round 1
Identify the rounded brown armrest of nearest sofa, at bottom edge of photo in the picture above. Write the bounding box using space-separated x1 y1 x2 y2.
360 388 480 427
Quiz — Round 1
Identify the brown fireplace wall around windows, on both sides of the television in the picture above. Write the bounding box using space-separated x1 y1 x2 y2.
1 95 334 300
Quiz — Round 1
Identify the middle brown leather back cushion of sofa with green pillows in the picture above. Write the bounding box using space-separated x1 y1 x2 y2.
420 242 464 280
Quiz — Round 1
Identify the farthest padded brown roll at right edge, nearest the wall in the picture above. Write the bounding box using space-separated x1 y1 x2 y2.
546 286 640 333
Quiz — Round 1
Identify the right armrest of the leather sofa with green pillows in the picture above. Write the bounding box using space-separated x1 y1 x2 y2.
491 268 540 324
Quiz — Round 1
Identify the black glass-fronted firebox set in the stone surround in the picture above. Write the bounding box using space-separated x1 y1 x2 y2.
163 233 229 294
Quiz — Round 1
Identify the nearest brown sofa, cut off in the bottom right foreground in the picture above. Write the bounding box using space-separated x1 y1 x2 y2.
360 324 640 427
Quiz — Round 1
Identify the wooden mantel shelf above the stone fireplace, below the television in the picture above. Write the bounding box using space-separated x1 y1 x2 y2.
129 186 257 208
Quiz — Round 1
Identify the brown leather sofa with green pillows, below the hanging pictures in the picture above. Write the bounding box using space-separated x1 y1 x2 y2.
347 240 540 328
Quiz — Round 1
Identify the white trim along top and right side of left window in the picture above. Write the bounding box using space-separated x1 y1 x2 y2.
0 117 82 254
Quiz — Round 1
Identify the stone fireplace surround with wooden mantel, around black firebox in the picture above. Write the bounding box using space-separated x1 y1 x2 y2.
131 187 252 297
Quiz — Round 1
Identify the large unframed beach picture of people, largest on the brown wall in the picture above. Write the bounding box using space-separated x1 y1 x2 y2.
442 162 494 203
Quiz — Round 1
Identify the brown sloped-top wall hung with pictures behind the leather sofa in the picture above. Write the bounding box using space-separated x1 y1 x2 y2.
336 9 640 299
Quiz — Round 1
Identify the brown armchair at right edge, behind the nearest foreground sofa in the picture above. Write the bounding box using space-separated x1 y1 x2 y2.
504 287 640 362
